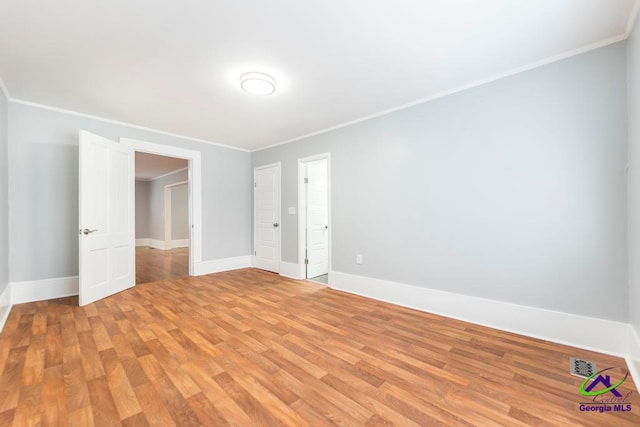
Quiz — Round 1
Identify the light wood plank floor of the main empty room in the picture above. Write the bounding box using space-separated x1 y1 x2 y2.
0 269 640 426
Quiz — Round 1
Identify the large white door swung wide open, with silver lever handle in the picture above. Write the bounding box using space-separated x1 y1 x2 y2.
79 131 135 306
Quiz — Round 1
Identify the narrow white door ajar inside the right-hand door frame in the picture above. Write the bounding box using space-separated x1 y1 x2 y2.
306 159 329 279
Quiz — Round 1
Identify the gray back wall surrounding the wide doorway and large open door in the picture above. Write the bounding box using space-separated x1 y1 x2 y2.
9 103 252 282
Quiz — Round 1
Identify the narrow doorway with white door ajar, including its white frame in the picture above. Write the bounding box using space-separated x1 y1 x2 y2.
298 153 331 284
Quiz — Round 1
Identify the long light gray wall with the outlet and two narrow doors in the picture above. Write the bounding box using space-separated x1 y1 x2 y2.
252 42 629 321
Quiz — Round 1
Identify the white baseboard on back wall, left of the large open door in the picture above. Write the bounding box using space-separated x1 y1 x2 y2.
9 276 78 304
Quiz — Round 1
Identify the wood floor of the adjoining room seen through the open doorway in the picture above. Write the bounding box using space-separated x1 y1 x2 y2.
136 246 189 283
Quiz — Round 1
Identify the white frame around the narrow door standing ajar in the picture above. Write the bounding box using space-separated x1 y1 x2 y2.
298 152 333 282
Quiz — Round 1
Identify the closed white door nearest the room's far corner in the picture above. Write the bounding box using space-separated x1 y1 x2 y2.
254 164 280 273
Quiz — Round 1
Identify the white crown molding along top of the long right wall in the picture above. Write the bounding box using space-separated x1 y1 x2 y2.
252 34 628 153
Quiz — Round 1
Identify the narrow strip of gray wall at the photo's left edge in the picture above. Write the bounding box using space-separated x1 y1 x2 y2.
0 90 9 295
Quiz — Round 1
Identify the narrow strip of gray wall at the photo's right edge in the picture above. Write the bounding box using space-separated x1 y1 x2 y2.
627 19 640 333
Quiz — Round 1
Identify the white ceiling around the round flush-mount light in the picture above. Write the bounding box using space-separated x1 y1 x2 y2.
0 0 637 150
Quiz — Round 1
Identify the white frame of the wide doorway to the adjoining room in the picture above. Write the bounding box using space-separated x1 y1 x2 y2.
120 138 202 276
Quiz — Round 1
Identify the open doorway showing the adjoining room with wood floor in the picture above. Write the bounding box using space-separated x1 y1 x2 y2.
135 152 190 284
